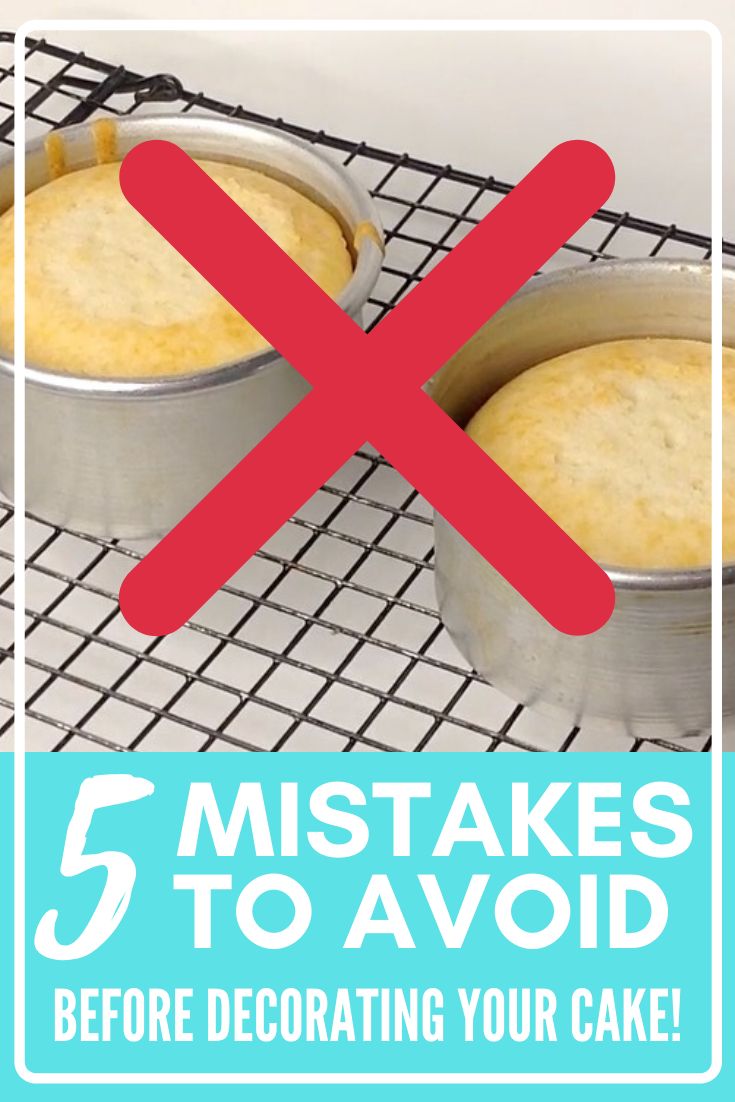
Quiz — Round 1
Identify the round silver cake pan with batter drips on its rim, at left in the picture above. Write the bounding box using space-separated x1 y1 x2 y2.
0 115 382 539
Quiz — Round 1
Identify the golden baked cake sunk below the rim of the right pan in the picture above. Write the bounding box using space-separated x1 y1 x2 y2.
467 338 735 569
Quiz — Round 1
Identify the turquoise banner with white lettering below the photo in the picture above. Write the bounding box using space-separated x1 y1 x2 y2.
0 754 735 1099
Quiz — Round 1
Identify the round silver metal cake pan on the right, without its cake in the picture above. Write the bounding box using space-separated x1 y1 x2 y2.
430 259 735 737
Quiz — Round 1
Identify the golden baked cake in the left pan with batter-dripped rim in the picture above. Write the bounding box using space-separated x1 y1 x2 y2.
0 161 353 377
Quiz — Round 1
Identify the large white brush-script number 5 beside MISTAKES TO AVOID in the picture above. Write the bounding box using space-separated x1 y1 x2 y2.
33 773 154 961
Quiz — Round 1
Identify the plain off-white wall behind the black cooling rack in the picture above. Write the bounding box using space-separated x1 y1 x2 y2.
2 0 735 239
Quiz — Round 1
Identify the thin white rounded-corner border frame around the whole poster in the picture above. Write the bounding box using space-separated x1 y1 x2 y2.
13 19 723 1084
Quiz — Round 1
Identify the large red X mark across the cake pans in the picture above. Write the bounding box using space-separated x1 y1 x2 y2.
120 141 615 635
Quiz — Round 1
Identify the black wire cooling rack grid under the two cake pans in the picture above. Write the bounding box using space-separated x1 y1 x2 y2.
0 34 735 752
